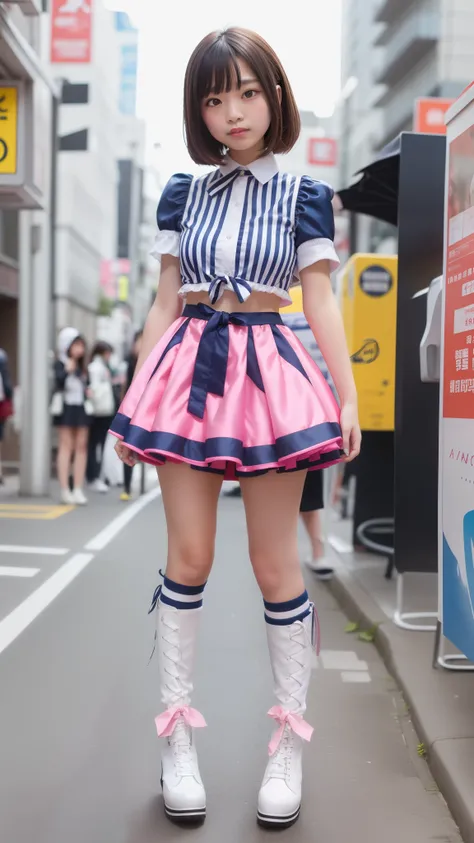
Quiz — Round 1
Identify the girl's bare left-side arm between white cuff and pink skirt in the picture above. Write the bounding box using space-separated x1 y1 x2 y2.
134 255 182 378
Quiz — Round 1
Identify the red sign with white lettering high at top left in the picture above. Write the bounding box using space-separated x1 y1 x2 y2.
51 0 92 64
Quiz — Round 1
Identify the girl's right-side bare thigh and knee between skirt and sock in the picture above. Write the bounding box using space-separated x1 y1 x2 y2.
241 471 305 602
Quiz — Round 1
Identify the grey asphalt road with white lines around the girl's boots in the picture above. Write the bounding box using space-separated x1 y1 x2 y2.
0 484 460 843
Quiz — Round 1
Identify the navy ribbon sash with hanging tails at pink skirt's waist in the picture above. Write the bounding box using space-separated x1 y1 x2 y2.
184 304 281 419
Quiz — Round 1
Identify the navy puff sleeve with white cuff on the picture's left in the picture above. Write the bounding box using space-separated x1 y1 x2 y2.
150 173 193 260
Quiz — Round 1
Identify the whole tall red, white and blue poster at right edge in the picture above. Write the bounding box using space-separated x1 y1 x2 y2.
441 120 474 659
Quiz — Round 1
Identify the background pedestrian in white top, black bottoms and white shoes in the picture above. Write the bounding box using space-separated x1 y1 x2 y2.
86 341 116 493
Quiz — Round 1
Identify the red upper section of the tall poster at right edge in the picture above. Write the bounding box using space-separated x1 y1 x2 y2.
443 128 474 419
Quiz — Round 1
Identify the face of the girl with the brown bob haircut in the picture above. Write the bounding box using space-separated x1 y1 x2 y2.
201 59 278 163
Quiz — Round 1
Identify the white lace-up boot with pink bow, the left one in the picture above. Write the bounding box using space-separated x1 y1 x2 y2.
156 602 206 822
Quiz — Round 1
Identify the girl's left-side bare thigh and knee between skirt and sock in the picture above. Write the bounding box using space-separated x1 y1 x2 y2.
158 462 222 585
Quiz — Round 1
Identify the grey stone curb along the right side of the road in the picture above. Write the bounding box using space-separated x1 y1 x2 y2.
328 567 474 843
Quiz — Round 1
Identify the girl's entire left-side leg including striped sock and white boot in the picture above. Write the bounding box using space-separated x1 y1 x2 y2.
156 463 222 821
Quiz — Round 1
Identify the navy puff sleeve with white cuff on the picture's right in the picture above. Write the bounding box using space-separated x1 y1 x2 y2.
295 176 339 273
